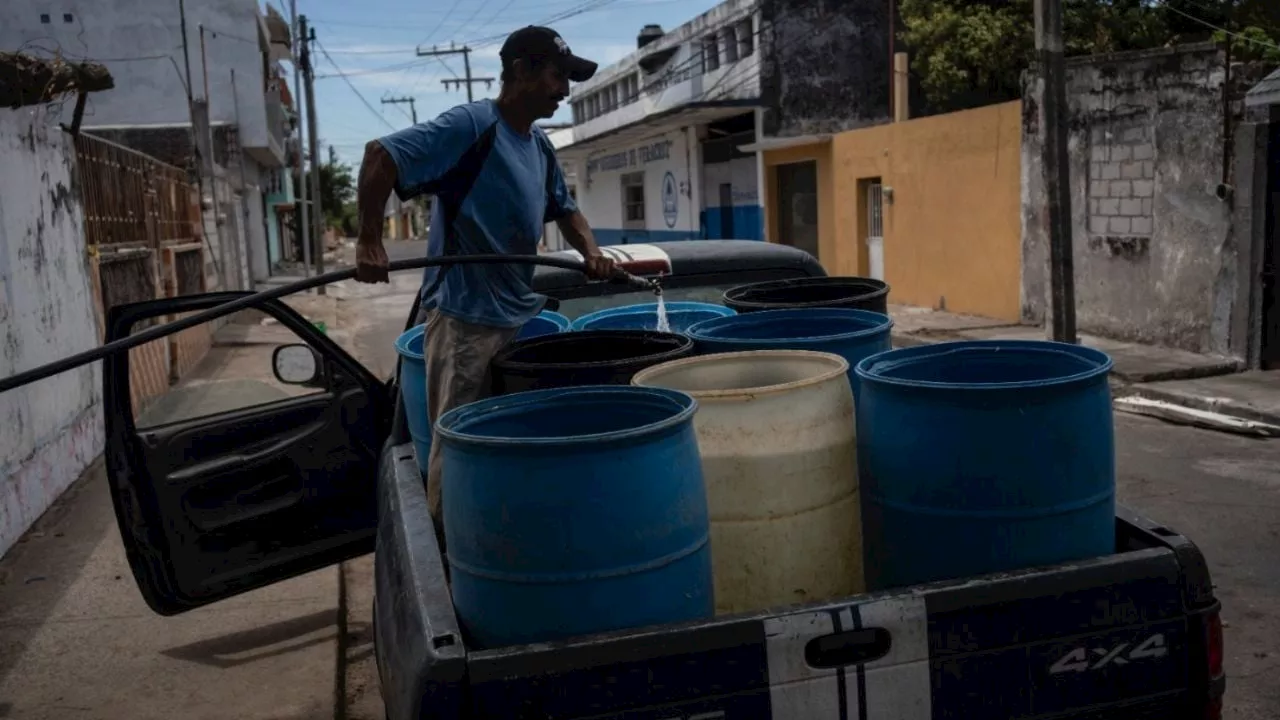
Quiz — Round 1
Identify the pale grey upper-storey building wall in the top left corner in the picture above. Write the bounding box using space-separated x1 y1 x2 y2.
0 0 268 146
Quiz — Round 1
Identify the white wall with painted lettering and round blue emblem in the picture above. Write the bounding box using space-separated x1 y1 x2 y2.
561 128 701 245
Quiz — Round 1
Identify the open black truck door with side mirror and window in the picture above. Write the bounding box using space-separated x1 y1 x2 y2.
102 292 393 615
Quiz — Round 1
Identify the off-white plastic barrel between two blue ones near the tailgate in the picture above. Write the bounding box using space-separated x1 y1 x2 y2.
631 350 864 614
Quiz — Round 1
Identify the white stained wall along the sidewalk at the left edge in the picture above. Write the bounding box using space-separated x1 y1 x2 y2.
0 108 104 555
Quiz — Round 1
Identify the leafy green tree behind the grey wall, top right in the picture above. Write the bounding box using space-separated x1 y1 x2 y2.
900 0 1280 111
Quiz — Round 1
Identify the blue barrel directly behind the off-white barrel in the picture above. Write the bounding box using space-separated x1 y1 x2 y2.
686 307 893 398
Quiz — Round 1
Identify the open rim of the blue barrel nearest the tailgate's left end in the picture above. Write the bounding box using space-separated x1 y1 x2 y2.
435 386 698 448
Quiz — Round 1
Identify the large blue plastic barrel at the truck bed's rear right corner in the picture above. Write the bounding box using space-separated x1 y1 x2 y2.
856 341 1115 589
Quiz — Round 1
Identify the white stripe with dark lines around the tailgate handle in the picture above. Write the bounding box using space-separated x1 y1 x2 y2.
764 596 933 720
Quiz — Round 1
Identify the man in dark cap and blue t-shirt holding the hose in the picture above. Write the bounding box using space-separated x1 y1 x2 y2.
356 26 614 539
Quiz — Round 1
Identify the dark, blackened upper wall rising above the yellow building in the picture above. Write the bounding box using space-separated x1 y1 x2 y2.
760 0 890 137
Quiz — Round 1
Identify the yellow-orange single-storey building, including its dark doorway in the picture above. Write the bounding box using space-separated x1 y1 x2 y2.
760 102 1021 322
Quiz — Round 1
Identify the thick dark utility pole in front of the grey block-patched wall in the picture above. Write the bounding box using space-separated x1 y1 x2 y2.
1036 0 1076 343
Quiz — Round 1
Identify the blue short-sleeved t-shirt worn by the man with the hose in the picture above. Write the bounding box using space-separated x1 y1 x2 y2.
379 100 577 328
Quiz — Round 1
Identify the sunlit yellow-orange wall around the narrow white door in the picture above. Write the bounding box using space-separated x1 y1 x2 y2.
832 102 1021 316
